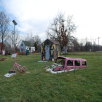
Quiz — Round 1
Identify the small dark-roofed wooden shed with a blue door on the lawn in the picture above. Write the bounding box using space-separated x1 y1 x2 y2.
41 39 60 60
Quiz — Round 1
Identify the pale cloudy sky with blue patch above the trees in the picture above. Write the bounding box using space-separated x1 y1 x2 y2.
0 0 102 45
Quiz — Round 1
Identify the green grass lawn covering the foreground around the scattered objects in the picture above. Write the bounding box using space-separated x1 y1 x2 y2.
0 52 102 102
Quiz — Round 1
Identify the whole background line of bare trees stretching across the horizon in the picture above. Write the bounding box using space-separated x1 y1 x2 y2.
0 11 102 53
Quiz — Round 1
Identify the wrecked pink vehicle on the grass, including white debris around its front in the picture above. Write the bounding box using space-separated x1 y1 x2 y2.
46 57 87 74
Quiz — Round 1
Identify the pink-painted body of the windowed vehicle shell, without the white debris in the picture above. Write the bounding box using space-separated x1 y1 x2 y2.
53 57 87 71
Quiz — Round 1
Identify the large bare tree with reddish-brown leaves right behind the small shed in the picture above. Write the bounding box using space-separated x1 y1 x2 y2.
47 14 76 52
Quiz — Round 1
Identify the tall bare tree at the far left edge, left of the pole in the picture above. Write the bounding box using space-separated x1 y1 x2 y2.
0 12 9 51
